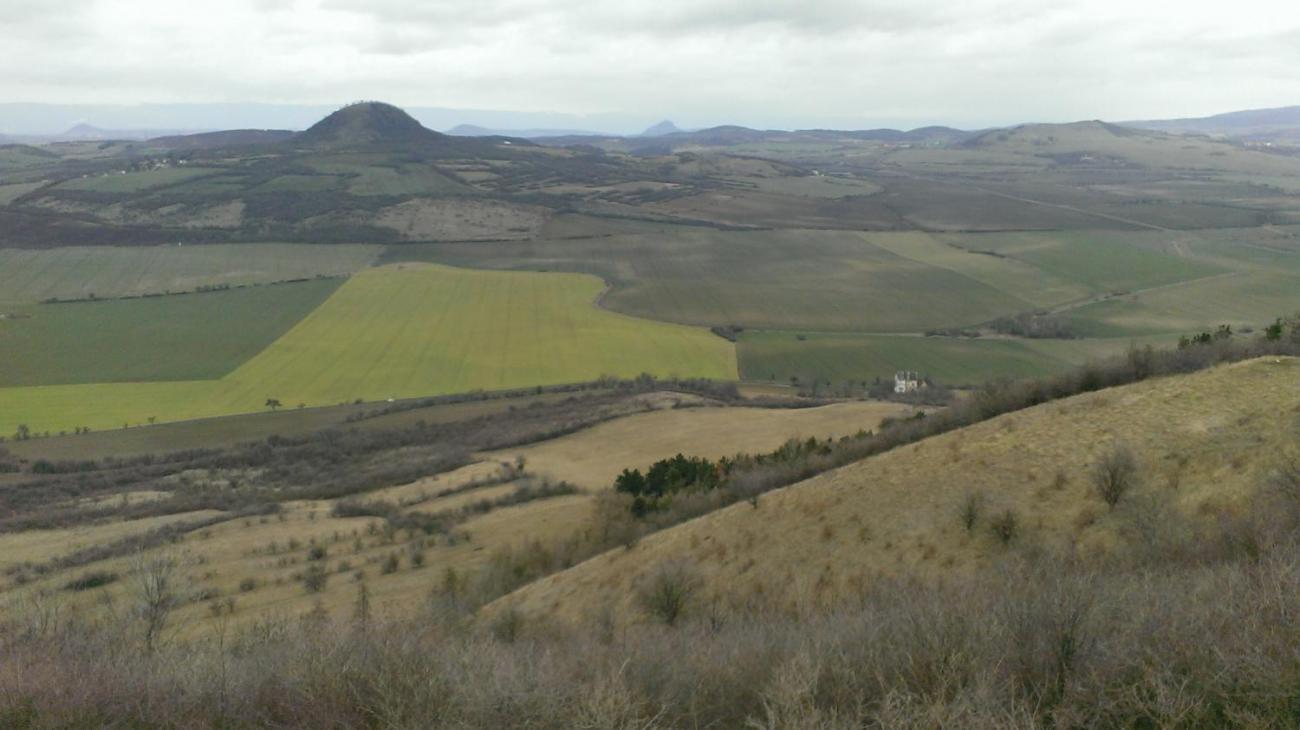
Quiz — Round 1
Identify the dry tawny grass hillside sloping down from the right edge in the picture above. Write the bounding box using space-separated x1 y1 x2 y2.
488 359 1300 622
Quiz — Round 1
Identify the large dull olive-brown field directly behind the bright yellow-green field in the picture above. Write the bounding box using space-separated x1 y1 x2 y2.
386 229 1034 333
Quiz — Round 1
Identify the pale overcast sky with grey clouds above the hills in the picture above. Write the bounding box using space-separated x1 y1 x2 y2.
0 0 1300 127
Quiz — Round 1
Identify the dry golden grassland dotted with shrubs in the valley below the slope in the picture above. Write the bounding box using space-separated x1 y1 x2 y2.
0 394 907 634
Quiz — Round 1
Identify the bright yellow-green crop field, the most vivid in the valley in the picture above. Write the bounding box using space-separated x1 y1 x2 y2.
0 264 737 433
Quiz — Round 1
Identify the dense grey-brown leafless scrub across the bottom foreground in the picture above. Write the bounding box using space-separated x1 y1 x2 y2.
10 522 1300 727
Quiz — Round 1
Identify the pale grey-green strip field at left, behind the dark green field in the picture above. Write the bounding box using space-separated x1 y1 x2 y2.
0 243 382 304
